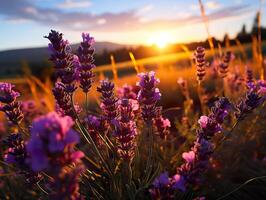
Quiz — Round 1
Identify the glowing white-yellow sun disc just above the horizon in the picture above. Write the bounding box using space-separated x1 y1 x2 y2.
147 32 172 49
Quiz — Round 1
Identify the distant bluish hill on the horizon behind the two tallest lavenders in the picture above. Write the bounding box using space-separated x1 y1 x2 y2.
0 42 130 77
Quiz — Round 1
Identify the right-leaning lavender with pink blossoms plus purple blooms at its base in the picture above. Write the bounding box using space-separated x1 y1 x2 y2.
150 98 230 199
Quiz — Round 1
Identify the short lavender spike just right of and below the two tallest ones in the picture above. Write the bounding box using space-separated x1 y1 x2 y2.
97 80 118 122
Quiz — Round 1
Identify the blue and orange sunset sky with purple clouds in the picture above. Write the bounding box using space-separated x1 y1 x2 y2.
0 0 266 50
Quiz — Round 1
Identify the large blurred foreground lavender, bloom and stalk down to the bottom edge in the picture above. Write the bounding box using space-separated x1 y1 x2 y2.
26 112 84 199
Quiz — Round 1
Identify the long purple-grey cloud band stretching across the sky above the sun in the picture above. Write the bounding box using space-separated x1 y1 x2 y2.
0 0 251 32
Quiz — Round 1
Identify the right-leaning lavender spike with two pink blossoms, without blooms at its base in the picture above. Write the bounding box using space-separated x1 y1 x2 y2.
172 97 230 190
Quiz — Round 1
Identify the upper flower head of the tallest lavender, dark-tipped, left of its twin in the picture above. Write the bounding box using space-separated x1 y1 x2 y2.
45 30 79 94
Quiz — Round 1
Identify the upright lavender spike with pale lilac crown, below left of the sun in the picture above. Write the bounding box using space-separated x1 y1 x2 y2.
137 71 161 123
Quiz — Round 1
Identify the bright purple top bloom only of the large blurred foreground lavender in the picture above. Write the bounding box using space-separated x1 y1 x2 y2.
27 112 83 171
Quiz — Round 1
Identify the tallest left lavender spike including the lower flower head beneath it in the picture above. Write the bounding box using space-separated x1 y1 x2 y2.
45 30 79 118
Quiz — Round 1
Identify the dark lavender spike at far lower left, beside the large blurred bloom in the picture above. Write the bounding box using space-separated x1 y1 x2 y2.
3 133 42 185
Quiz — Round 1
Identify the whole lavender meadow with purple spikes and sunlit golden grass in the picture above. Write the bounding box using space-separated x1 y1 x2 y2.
0 26 266 200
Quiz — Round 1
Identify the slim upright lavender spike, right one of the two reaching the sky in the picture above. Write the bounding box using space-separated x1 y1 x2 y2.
78 33 95 93
